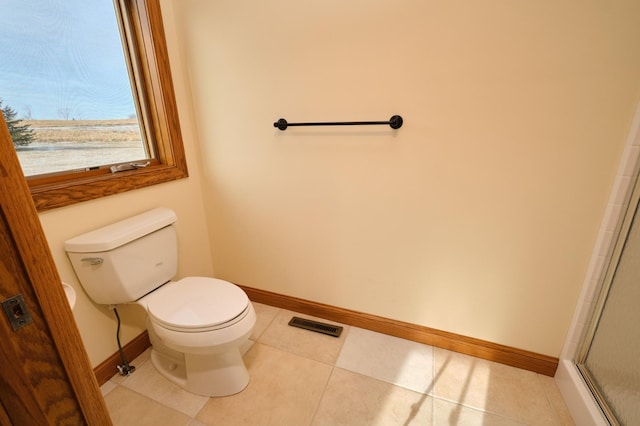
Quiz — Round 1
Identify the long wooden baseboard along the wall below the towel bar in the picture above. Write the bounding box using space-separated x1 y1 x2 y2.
239 286 558 377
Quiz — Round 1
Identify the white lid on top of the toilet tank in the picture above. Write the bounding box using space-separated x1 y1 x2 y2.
64 207 177 253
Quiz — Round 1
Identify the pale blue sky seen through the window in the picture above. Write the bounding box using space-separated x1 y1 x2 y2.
0 0 135 120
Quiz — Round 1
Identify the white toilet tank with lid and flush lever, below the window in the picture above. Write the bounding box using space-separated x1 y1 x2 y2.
64 208 178 305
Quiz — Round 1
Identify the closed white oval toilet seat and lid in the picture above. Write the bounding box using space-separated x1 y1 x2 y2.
145 277 249 333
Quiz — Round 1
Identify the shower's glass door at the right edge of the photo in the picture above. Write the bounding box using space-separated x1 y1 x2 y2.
577 183 640 425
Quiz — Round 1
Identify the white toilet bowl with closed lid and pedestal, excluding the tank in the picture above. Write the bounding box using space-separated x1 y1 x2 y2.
136 277 256 396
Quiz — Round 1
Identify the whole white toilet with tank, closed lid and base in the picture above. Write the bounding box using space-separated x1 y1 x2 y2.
65 208 256 396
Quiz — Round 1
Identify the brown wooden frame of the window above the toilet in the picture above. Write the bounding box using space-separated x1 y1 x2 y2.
27 0 189 211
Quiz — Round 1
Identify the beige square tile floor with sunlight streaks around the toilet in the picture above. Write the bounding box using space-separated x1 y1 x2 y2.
102 303 573 426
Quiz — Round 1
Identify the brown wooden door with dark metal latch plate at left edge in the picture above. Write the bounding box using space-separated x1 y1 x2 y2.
0 114 111 426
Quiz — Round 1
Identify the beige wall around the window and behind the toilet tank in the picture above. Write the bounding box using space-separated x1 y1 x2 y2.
40 1 213 367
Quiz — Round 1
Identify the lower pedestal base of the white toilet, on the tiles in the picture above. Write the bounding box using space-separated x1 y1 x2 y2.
151 348 249 397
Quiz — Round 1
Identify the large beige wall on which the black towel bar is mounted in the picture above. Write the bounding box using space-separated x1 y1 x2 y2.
172 0 640 356
